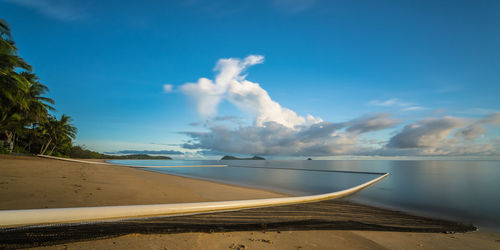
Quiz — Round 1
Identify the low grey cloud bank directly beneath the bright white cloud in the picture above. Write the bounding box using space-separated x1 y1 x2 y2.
182 114 397 156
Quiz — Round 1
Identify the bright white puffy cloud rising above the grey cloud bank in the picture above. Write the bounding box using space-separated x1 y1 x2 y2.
181 55 321 128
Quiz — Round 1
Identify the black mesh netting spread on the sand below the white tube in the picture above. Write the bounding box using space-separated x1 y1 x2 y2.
0 200 476 248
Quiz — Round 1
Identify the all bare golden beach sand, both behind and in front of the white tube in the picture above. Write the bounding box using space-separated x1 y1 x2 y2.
0 155 500 249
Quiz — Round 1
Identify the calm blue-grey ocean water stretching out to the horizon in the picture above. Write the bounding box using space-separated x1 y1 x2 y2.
111 160 500 231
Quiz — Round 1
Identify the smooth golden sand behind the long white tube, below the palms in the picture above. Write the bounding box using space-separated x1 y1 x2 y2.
0 155 283 210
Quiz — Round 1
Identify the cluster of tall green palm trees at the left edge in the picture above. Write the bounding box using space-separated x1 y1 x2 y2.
0 19 77 156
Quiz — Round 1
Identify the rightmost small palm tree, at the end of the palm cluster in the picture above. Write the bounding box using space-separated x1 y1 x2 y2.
40 114 77 155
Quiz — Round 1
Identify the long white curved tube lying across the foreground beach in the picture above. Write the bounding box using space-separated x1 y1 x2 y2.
0 155 389 227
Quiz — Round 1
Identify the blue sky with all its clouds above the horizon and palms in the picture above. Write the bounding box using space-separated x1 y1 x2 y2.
0 0 500 159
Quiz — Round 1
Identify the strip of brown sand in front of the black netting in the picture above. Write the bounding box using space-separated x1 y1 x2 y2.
35 230 500 250
